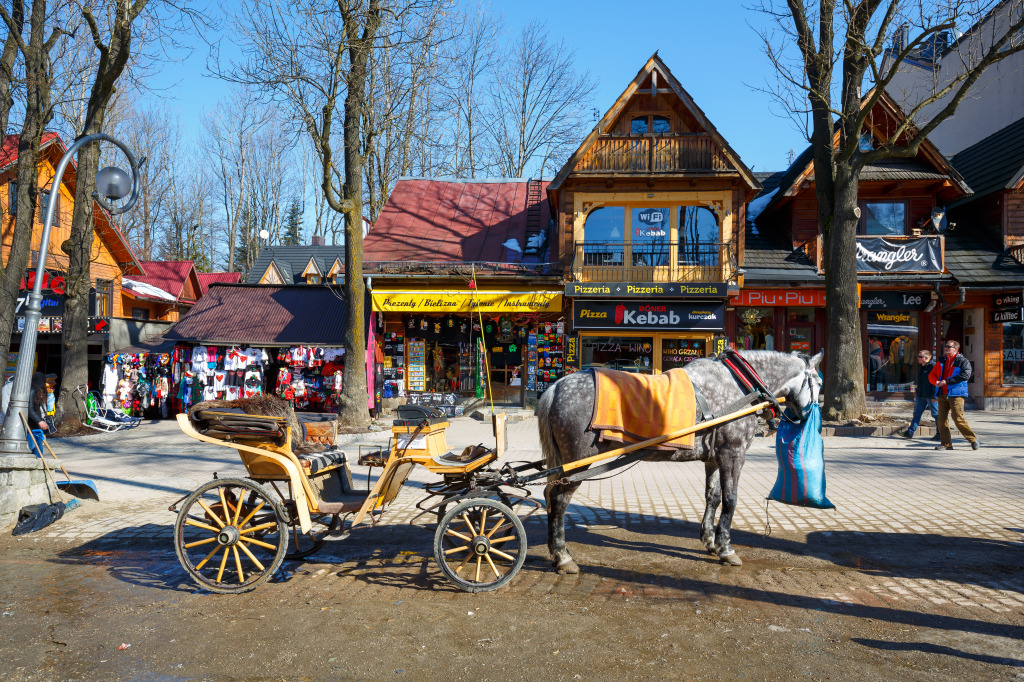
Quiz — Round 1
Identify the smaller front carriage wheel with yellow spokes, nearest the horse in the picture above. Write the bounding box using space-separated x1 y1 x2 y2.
434 498 526 592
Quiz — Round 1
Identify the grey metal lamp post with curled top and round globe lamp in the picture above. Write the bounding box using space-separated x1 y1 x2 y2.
0 133 139 453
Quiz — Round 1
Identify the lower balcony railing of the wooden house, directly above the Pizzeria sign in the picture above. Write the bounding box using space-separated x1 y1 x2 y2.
571 241 736 282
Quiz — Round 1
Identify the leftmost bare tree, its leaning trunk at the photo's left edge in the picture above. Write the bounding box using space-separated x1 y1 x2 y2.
0 0 67 374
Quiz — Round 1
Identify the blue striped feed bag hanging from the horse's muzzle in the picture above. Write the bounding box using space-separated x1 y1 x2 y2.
768 403 836 509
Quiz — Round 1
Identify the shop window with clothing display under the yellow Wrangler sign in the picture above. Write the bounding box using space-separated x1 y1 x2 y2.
867 310 920 392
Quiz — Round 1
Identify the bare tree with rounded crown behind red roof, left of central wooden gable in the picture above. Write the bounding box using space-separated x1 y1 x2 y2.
487 23 595 177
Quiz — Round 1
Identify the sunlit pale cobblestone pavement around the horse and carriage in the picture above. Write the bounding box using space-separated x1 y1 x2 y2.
22 413 1024 614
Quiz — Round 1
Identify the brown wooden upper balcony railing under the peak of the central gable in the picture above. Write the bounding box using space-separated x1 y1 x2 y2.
575 133 730 173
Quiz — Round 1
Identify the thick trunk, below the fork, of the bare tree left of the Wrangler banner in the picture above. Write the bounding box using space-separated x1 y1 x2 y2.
824 162 866 420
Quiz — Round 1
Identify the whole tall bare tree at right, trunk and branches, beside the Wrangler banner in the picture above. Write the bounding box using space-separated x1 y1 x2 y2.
761 0 1024 419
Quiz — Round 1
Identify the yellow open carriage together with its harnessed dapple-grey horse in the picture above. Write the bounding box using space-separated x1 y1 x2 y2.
170 353 820 593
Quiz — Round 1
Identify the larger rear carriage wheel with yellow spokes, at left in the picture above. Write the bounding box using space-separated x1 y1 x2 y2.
174 478 288 594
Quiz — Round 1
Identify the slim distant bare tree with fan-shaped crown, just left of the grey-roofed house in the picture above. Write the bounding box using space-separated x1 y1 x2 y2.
203 89 271 272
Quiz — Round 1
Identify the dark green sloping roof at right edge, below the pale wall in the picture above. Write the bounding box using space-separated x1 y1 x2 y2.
951 118 1024 200
